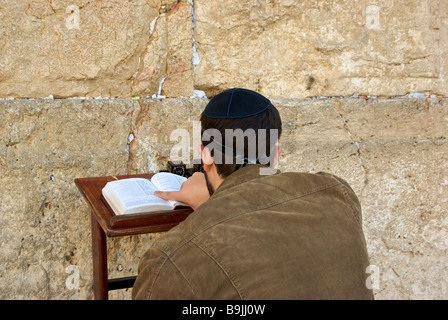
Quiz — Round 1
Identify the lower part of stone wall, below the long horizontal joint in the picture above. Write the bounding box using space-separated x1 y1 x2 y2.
0 98 448 299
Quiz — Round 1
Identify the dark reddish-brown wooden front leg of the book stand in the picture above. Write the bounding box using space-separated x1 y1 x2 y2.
90 214 109 300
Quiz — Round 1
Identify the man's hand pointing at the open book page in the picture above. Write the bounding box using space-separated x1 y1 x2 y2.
154 172 210 210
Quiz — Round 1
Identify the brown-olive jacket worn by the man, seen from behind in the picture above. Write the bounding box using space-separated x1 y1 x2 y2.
132 165 373 299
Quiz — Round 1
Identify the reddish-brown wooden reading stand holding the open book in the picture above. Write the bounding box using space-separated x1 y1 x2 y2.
75 173 193 300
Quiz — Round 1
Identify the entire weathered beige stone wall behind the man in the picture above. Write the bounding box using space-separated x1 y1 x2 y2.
0 0 448 299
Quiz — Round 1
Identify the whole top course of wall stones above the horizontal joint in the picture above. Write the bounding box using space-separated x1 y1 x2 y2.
0 0 448 98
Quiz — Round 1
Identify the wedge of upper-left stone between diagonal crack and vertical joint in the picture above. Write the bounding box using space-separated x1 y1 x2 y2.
132 2 194 97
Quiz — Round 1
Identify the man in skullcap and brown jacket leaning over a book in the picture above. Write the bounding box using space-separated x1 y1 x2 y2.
133 89 373 299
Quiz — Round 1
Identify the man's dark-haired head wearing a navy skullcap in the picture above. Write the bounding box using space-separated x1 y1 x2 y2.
201 88 282 193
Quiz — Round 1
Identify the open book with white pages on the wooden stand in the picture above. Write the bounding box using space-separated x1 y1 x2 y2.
102 172 188 215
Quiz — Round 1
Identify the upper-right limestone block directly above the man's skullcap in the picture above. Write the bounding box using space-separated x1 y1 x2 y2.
194 0 448 98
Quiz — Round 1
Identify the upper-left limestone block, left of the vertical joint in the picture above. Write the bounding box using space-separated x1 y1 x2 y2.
0 0 193 98
